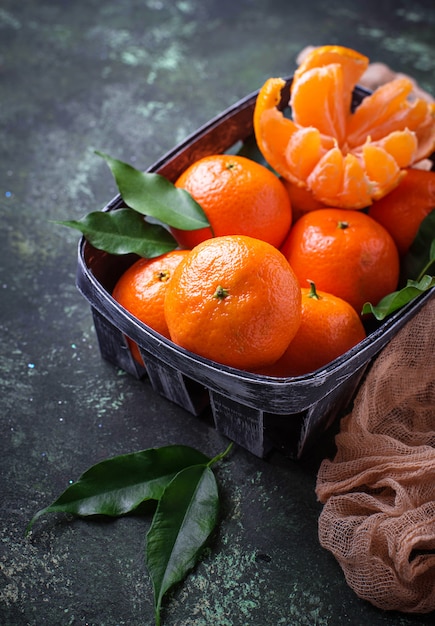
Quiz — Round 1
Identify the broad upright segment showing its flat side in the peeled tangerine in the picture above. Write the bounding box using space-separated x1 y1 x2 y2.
290 63 349 144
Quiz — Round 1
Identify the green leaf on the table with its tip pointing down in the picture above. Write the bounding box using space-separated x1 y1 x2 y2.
146 465 219 625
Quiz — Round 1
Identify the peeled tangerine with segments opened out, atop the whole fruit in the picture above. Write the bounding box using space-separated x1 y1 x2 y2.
254 46 435 209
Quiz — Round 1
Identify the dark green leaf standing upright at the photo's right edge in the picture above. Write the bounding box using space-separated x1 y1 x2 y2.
402 210 435 280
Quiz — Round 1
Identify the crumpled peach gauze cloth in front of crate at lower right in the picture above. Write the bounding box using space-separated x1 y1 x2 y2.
316 297 435 613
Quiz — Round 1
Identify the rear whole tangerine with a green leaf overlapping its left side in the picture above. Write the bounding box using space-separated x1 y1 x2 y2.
172 154 292 249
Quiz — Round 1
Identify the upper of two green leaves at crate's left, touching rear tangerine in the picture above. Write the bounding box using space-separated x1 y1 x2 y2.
97 151 210 230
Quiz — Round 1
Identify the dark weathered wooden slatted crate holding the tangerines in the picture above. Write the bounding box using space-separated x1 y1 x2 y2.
77 79 435 459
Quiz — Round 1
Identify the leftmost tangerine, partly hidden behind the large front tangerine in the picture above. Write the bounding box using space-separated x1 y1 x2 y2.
112 250 187 363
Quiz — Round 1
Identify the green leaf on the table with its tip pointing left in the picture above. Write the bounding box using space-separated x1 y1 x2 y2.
26 445 209 534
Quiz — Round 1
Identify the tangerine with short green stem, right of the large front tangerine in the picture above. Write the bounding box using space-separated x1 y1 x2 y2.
262 283 366 377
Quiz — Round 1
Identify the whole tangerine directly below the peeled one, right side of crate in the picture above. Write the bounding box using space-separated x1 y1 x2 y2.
281 208 399 313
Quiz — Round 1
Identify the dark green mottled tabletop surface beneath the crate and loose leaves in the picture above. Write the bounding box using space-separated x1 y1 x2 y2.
0 0 435 626
